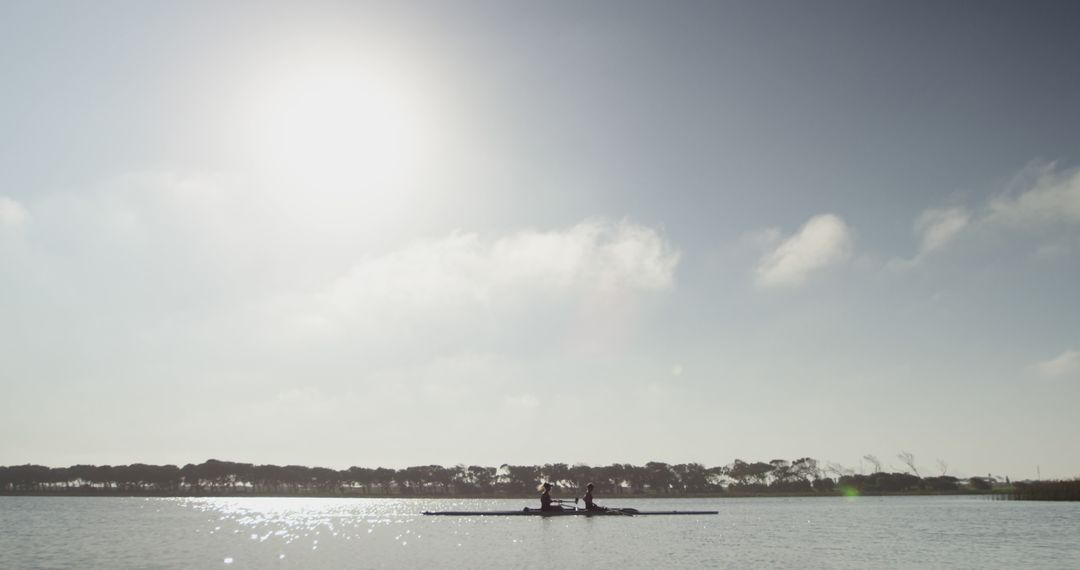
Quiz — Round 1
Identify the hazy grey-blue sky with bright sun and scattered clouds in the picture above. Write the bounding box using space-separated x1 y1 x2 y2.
0 0 1080 479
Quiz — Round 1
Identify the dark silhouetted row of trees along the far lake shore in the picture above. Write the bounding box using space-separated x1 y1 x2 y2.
0 458 1002 497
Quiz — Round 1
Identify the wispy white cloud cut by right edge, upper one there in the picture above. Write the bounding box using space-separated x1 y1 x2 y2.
986 163 1080 227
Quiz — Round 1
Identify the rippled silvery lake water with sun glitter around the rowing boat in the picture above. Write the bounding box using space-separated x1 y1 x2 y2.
0 497 1080 570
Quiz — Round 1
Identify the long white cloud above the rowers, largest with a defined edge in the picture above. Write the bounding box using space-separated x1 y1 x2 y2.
274 216 679 338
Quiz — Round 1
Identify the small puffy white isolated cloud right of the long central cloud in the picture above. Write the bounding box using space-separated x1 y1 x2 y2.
755 214 853 286
